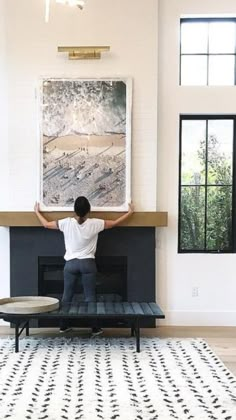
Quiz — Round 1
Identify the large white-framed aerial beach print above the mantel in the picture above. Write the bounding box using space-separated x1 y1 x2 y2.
39 78 132 211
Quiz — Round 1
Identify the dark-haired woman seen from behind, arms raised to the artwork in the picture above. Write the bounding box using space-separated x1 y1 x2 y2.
34 196 134 335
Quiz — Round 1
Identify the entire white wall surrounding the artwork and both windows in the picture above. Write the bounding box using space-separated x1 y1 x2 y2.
0 0 236 325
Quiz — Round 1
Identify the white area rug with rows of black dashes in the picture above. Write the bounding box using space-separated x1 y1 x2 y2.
0 337 236 420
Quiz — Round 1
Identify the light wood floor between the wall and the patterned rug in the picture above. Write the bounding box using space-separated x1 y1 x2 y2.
0 326 236 376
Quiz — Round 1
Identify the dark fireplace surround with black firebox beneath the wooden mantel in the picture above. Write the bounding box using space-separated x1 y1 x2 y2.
10 227 155 327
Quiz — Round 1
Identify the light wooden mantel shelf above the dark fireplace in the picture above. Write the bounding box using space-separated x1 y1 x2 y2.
0 211 168 227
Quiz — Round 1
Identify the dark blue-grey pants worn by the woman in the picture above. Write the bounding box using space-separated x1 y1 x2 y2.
62 258 97 303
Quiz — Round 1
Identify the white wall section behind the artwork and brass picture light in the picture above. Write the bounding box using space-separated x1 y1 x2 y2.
0 0 158 316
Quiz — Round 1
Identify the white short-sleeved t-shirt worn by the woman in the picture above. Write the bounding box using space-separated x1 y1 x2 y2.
58 217 105 261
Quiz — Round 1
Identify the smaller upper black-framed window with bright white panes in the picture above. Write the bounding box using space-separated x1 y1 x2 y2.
180 18 236 86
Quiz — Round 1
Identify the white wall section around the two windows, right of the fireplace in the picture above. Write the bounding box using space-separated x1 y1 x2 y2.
157 0 236 325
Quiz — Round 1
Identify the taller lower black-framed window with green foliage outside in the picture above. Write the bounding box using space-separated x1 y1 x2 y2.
178 115 236 252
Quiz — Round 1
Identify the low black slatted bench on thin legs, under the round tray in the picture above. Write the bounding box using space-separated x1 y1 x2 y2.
0 302 165 353
